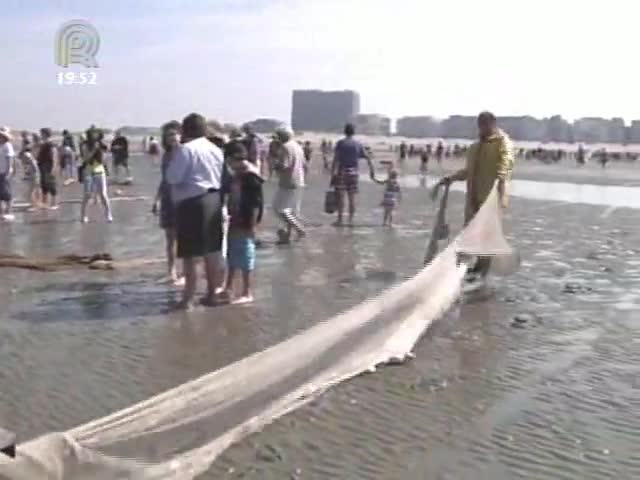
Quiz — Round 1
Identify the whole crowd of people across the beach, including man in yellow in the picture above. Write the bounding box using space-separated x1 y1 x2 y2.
0 112 536 310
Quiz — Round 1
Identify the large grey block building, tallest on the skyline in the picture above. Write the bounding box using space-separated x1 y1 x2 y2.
291 90 360 132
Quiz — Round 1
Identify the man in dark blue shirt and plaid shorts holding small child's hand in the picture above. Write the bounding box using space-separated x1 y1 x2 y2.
331 123 374 227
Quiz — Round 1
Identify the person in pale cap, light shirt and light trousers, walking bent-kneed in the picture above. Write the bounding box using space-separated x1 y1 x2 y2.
273 126 305 244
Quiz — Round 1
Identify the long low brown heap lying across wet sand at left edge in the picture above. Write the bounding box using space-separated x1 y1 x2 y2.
0 253 164 272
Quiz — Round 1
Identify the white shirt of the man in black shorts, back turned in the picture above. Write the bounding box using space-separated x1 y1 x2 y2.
166 137 224 203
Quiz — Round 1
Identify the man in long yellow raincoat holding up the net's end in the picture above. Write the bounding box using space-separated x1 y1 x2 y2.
437 112 514 281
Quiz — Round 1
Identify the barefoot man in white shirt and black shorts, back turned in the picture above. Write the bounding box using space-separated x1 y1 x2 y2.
166 113 225 310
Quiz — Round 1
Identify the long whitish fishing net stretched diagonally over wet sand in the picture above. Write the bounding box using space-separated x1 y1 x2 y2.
0 182 508 480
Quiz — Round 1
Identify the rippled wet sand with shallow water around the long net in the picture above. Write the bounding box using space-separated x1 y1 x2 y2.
0 159 640 480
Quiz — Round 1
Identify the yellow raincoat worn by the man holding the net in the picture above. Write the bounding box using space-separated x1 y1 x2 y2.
451 130 513 221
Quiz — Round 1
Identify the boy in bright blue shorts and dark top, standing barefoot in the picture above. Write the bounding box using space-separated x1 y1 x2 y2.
224 142 264 304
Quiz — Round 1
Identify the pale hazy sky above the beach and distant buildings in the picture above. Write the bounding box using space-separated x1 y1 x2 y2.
0 0 640 129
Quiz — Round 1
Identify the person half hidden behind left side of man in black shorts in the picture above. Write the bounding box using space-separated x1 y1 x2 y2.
152 120 184 287
